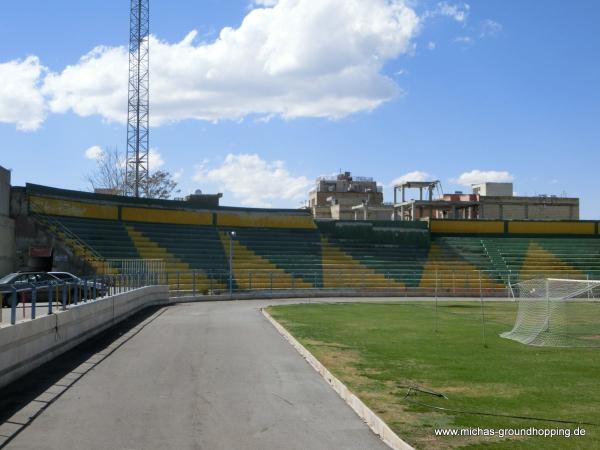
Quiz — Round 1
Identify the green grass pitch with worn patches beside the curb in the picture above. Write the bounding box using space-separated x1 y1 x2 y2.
269 301 600 449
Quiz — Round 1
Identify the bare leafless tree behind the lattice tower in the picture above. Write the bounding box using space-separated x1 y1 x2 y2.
86 147 180 199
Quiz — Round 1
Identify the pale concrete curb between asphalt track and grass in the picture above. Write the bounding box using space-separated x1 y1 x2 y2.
260 308 414 450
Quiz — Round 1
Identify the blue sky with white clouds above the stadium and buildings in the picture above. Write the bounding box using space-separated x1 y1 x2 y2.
0 0 600 219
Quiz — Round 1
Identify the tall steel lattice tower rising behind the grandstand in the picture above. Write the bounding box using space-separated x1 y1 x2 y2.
125 0 150 197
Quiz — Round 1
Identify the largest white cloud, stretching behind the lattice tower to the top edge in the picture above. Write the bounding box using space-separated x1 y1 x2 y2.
43 0 420 126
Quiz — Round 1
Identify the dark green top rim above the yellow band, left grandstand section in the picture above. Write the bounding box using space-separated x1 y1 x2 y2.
25 183 311 216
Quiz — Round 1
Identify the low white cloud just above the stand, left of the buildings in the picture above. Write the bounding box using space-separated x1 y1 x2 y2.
193 154 311 207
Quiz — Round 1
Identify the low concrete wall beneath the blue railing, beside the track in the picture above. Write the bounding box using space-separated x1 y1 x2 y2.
0 286 169 388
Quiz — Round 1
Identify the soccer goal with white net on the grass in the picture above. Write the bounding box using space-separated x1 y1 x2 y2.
500 278 600 347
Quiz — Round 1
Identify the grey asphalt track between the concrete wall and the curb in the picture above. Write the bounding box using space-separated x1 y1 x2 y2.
0 301 387 450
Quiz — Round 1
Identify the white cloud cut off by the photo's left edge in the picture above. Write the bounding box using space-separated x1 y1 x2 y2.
0 56 46 131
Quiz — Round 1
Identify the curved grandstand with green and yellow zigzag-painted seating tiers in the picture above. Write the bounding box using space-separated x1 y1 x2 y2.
4 179 600 296
